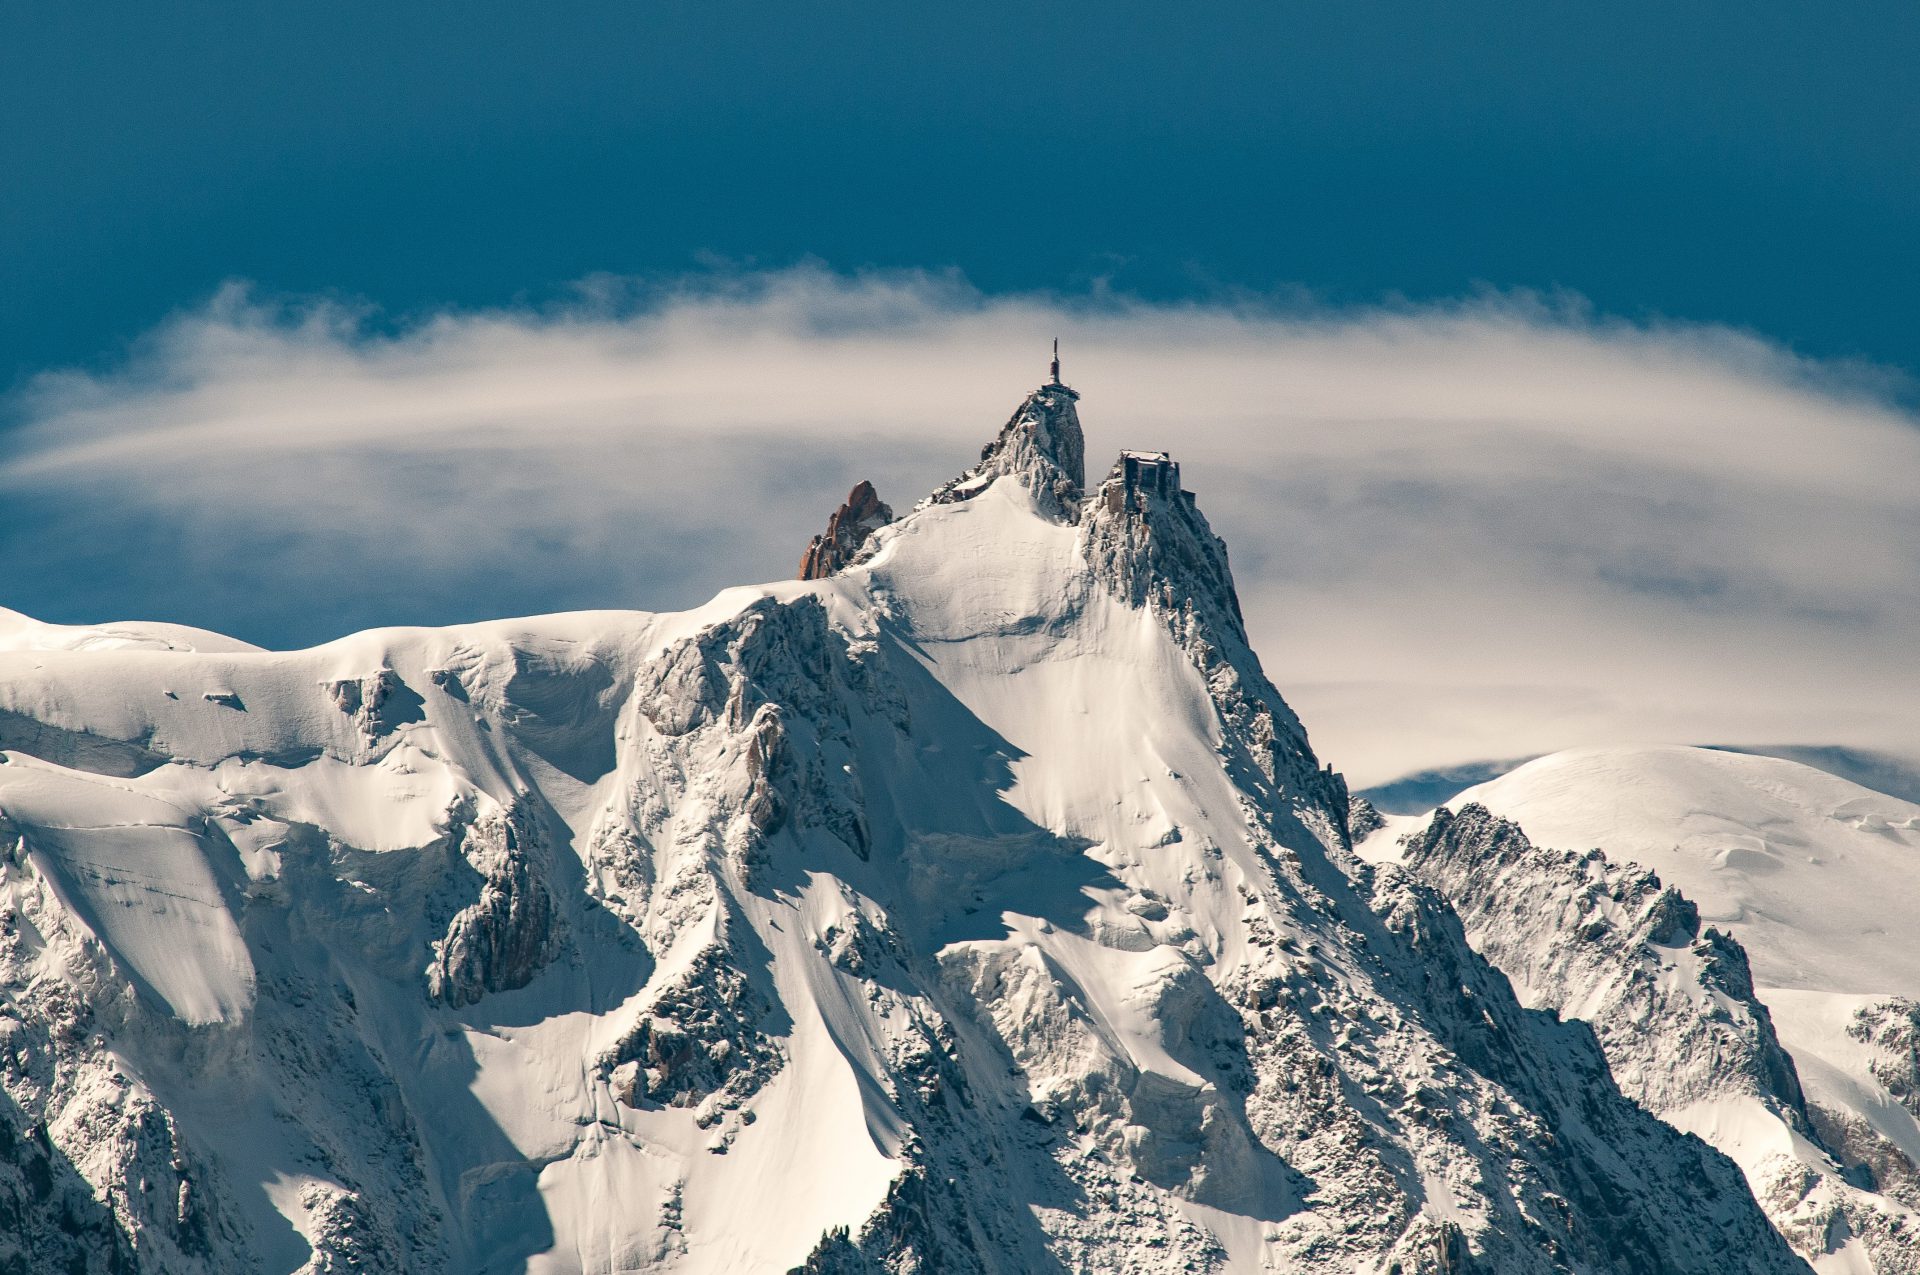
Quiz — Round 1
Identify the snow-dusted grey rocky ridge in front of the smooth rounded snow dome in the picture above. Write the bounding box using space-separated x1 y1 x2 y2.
1400 805 1920 1275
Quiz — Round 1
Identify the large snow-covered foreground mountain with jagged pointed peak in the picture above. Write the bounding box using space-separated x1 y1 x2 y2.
0 386 1807 1275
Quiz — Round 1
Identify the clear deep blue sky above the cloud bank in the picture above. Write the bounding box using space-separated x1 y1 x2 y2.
11 0 1920 386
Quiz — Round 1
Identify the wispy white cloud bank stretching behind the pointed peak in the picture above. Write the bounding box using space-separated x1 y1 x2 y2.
0 271 1920 783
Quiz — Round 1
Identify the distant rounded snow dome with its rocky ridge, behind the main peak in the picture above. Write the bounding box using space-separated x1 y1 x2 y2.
1359 745 1920 1271
